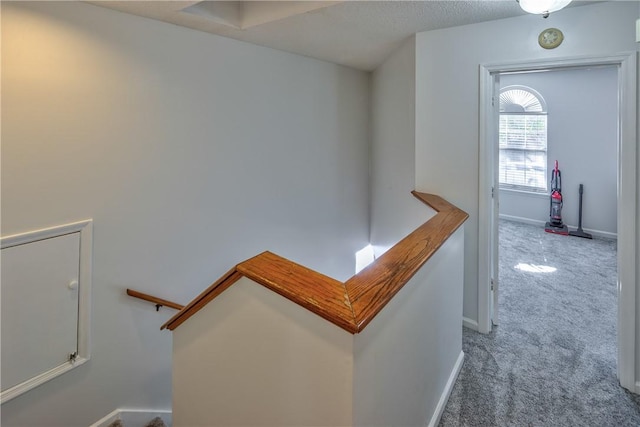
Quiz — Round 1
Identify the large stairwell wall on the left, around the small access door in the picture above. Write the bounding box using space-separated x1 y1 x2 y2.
1 2 369 426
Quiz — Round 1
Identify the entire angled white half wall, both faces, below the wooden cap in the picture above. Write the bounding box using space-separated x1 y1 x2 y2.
173 228 464 427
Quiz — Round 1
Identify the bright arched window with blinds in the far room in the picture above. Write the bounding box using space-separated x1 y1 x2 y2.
499 86 548 193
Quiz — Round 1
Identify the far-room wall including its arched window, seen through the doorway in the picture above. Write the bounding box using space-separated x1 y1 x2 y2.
496 65 619 239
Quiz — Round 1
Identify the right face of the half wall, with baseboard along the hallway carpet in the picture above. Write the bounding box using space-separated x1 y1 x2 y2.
353 228 464 427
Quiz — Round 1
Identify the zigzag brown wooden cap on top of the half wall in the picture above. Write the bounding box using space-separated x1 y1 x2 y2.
161 191 469 334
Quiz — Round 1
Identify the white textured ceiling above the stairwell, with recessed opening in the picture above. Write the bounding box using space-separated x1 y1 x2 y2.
88 0 600 71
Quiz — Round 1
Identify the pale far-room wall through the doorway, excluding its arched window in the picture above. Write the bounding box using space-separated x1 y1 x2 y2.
500 66 618 236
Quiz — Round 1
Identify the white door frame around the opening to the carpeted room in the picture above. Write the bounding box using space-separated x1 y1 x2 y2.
478 52 640 393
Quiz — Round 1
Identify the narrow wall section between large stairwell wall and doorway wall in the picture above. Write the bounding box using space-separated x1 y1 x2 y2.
370 37 437 256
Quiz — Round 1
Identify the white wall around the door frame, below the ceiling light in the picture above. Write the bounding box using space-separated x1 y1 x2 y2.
416 1 640 326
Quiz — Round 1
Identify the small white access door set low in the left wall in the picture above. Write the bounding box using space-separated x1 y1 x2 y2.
0 233 80 392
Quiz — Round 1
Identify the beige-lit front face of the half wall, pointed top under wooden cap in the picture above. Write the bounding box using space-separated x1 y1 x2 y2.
173 277 355 427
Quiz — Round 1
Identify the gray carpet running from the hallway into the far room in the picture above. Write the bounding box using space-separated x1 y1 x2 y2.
440 221 640 427
